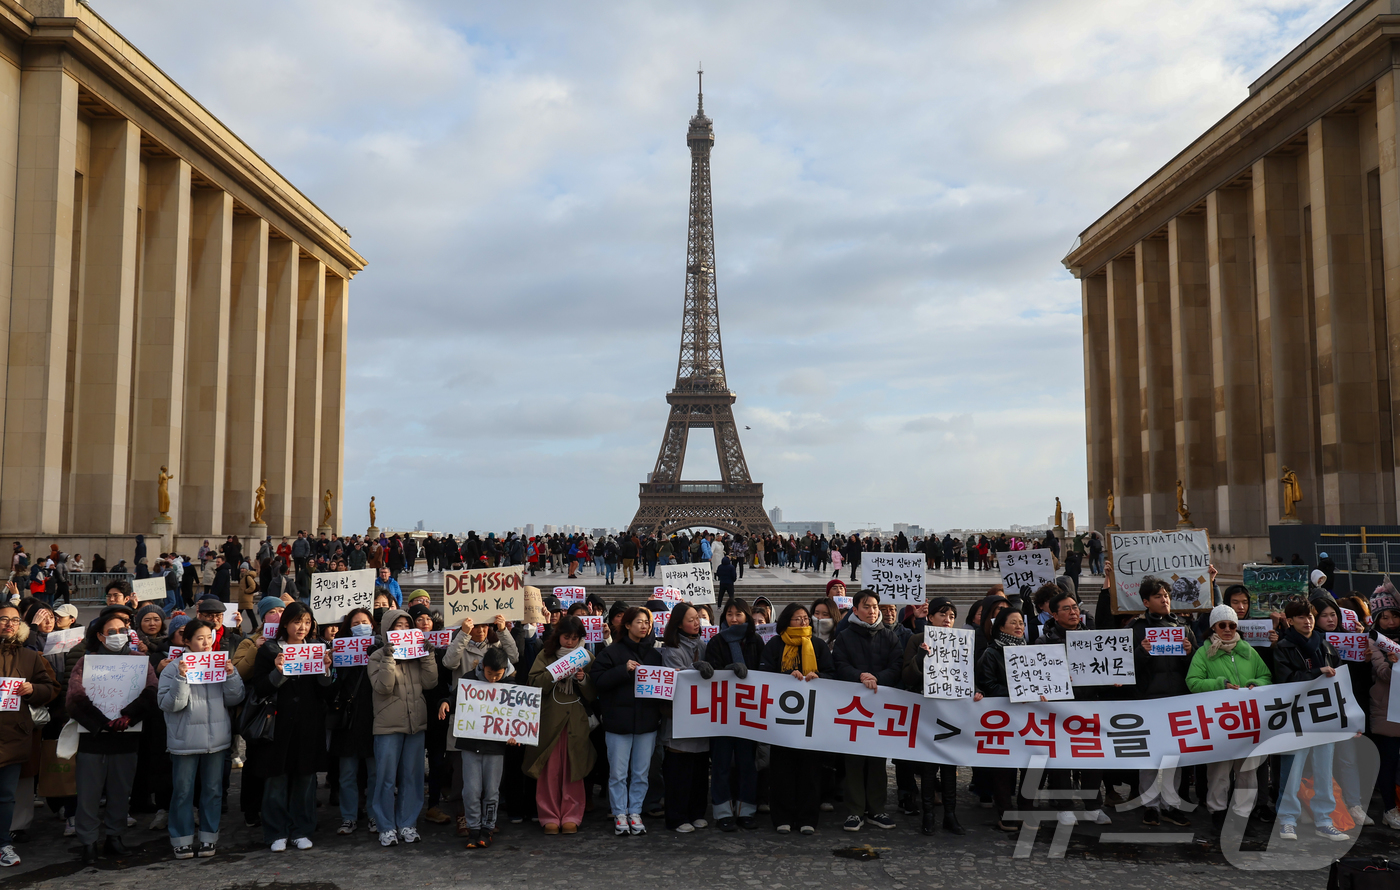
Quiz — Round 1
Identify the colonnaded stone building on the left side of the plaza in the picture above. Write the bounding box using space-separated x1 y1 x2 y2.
0 0 364 561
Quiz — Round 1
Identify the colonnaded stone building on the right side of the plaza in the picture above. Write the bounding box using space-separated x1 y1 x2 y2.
1064 0 1400 567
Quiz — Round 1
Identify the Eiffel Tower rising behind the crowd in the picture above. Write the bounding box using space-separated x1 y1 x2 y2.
631 70 773 535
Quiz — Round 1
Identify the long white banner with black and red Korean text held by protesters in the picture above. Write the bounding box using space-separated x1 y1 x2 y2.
672 670 1360 770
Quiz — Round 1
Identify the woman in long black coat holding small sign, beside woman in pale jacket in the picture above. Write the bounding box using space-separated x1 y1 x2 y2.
246 602 333 852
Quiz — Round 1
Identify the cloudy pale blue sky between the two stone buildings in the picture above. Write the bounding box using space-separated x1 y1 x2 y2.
98 0 1343 530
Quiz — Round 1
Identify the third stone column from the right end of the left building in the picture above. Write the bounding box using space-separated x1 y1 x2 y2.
262 238 301 537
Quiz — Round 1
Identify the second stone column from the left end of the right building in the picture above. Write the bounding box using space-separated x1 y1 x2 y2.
1107 256 1142 530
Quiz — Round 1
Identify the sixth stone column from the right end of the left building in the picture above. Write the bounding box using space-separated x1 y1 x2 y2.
127 158 190 529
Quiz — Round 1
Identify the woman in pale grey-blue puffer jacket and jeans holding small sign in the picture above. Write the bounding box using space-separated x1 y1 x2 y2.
155 615 244 859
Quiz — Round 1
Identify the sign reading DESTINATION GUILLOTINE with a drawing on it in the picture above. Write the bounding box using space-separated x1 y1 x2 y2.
1105 529 1214 614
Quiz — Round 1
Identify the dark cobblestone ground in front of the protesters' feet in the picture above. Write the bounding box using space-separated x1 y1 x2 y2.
0 771 1377 890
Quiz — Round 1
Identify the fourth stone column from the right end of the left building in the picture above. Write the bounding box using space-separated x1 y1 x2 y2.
224 216 267 533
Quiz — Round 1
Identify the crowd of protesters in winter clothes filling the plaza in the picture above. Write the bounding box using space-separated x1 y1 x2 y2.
0 533 1377 866
